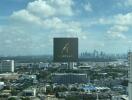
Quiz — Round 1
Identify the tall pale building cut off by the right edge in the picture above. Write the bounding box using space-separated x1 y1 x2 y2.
128 52 132 100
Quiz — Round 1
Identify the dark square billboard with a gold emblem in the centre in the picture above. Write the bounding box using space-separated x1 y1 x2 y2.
53 38 78 62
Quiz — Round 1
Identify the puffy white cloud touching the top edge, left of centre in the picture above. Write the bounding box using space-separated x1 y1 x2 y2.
27 0 74 18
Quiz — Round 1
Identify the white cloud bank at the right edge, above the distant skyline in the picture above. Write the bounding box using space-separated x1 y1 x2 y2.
97 12 132 39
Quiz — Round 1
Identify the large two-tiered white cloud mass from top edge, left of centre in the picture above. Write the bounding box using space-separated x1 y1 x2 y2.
11 0 81 34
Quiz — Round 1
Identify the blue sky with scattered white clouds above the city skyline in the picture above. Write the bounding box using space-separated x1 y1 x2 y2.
0 0 132 56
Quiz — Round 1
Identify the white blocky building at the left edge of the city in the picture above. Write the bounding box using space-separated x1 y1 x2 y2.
0 60 14 73
